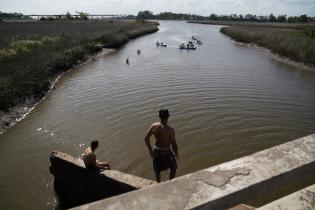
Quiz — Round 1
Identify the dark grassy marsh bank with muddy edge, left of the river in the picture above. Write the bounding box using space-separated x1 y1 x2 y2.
0 21 158 134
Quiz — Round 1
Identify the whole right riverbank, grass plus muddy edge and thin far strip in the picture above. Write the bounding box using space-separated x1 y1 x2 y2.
193 21 315 69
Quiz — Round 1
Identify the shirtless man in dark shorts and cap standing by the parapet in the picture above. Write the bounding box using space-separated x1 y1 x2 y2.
144 108 179 183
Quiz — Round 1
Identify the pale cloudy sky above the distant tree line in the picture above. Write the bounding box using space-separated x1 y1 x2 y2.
0 0 315 16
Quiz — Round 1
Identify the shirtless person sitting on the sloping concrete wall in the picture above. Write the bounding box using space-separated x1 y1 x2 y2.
82 140 110 170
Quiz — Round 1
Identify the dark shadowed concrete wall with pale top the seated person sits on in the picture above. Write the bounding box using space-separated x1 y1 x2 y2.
50 152 155 208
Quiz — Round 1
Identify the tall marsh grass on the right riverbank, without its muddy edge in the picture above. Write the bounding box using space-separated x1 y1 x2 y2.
221 26 315 66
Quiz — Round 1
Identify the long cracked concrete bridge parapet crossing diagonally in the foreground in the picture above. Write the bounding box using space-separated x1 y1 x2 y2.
71 135 315 210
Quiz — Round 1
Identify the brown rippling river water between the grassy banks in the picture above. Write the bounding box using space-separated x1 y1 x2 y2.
0 21 315 209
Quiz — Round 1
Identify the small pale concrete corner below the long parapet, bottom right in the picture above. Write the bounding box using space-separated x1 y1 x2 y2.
257 185 315 210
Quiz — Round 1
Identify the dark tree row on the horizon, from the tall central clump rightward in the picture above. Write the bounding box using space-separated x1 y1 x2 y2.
137 10 315 23
